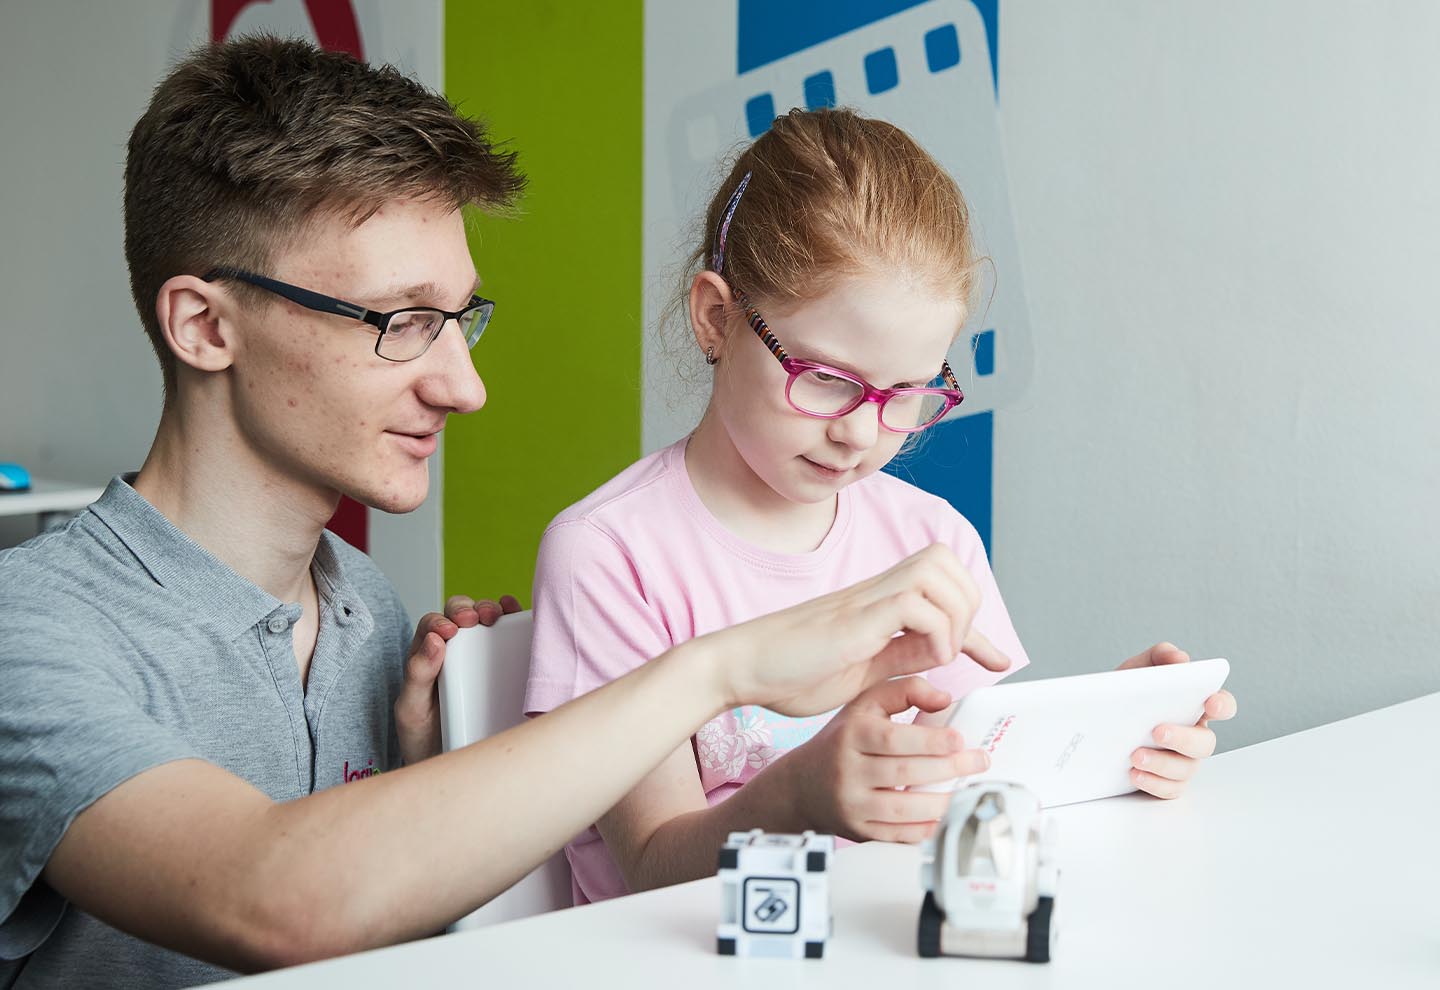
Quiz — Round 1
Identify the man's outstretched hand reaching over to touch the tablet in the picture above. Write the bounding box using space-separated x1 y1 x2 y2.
708 544 1009 715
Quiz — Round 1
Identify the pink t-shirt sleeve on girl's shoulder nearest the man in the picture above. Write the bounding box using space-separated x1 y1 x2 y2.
526 519 672 715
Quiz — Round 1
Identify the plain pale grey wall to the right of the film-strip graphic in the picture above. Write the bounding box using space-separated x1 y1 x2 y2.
995 0 1440 745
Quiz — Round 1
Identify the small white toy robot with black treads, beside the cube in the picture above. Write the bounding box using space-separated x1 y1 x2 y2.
919 780 1060 963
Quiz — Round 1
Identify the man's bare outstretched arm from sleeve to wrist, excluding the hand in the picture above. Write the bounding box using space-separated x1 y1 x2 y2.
43 645 731 971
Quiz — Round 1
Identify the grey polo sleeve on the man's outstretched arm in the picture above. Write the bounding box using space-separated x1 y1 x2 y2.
0 604 199 960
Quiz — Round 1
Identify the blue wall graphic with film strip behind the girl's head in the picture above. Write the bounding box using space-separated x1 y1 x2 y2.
725 0 1031 550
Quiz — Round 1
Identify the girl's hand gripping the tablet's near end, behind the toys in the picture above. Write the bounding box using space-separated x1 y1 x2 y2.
776 678 989 842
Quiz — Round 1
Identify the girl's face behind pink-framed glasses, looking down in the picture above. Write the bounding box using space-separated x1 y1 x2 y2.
710 276 965 504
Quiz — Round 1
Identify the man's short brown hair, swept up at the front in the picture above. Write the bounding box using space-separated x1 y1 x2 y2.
125 35 524 396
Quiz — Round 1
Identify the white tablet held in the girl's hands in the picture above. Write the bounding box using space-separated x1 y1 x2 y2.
919 659 1230 807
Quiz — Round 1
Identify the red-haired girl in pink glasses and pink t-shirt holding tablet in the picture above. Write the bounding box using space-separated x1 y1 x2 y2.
526 109 1234 904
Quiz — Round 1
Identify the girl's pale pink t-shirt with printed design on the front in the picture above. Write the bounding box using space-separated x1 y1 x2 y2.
526 440 1028 904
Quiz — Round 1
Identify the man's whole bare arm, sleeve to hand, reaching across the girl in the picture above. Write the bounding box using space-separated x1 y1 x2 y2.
43 548 978 970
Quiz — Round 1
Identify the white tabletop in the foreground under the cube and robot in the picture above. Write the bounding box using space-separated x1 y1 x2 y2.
221 694 1440 990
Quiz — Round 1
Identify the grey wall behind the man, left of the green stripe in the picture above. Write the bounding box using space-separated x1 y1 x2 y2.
0 0 444 614
